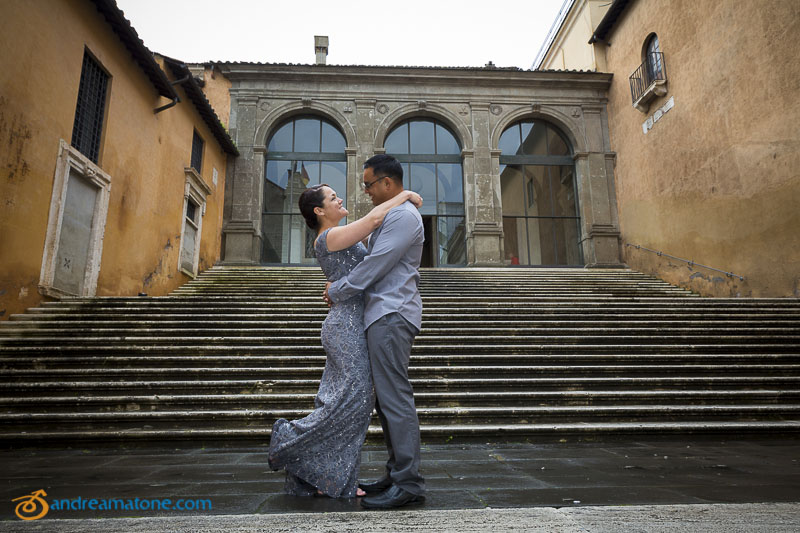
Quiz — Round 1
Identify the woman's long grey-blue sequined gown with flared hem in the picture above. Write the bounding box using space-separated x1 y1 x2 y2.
269 230 375 498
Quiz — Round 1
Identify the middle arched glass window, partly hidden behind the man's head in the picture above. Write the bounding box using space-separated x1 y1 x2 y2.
384 118 467 266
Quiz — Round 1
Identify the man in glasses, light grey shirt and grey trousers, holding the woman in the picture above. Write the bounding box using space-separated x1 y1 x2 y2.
323 154 425 509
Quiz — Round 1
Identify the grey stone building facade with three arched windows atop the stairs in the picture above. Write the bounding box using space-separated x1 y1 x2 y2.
212 63 620 267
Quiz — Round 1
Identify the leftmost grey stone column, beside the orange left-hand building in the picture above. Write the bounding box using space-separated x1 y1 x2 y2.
222 96 264 264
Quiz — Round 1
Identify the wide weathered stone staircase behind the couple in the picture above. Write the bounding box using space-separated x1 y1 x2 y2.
0 266 800 446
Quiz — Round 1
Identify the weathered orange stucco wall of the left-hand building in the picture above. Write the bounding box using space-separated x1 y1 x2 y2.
0 0 226 319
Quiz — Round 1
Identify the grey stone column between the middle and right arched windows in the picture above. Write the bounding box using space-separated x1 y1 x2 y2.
462 102 503 266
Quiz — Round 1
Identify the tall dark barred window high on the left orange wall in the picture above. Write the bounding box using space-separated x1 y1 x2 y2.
72 51 109 163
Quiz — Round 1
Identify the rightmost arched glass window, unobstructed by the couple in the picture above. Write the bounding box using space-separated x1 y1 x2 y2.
498 120 583 265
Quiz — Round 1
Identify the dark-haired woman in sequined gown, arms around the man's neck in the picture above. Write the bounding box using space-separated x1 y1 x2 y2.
269 184 422 498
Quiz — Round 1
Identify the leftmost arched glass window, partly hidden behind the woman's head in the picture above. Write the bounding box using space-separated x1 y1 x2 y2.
261 116 347 264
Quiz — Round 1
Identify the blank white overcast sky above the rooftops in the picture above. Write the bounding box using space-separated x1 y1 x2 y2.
117 0 563 69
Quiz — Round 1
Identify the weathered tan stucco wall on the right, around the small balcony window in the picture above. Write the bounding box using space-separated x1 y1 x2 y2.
606 0 800 297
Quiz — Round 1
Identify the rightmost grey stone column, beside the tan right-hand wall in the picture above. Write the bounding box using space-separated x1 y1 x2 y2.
574 106 623 268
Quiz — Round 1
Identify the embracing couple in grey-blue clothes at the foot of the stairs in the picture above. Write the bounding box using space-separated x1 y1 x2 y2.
269 154 425 509
